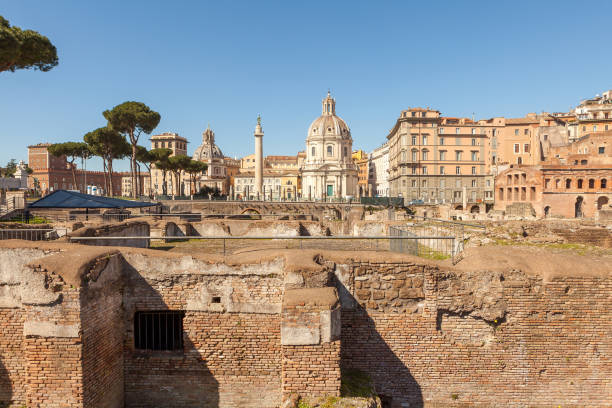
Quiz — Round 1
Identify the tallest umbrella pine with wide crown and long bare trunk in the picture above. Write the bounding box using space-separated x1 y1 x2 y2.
103 102 161 198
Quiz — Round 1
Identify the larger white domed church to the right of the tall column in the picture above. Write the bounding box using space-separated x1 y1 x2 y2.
302 92 357 200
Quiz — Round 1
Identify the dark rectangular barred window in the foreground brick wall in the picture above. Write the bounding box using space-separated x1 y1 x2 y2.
134 310 185 351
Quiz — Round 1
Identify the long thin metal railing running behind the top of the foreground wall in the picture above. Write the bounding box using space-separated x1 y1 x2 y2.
69 235 455 259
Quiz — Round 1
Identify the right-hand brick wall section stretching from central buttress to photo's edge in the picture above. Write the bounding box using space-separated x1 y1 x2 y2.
338 262 612 407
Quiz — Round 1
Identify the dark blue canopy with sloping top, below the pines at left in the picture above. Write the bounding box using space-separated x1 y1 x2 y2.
28 190 156 208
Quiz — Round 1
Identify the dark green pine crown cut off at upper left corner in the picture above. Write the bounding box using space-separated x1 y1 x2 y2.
0 16 58 72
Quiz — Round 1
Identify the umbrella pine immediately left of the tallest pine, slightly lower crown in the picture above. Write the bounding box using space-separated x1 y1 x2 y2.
83 127 131 196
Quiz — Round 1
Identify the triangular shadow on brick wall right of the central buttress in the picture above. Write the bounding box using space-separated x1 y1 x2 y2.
335 279 423 408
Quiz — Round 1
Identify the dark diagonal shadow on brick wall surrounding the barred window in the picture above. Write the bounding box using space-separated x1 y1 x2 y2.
123 262 219 408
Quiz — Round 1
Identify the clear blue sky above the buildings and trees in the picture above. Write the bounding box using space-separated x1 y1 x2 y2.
0 0 612 169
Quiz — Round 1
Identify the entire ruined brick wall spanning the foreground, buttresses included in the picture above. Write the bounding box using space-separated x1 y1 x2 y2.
0 241 612 408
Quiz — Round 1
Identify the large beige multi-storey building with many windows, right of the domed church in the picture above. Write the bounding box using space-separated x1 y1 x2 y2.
387 108 494 208
